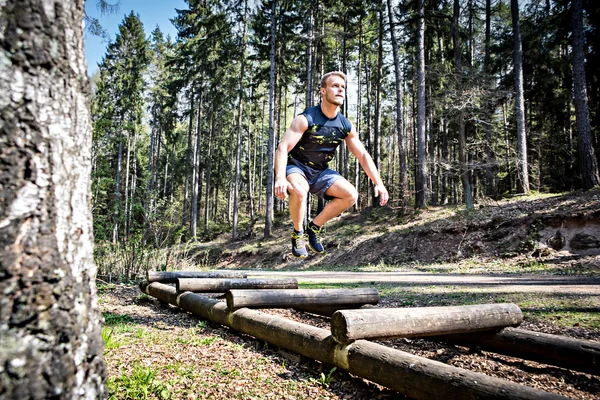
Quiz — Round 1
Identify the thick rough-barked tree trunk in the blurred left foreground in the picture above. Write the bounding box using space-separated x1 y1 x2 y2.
0 0 106 399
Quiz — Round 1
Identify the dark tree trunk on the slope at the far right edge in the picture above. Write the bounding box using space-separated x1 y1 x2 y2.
571 0 600 190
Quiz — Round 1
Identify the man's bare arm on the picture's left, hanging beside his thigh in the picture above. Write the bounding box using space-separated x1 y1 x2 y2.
275 115 308 200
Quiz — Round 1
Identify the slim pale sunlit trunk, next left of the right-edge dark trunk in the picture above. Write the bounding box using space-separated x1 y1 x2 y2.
510 0 529 193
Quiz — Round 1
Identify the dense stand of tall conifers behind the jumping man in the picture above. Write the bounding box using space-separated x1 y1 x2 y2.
92 0 600 275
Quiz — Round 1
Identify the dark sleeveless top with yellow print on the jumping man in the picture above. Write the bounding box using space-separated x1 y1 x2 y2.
288 105 352 170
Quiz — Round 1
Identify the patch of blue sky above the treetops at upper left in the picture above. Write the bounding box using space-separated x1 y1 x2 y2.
85 0 187 75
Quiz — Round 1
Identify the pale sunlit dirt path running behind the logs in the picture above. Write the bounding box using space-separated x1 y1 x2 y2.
247 271 600 296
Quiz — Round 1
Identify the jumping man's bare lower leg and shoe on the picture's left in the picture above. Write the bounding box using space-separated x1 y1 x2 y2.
287 173 309 258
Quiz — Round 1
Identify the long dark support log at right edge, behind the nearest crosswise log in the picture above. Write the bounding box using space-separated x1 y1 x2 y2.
434 328 600 375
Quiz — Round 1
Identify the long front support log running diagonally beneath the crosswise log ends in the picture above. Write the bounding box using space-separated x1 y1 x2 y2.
141 283 565 400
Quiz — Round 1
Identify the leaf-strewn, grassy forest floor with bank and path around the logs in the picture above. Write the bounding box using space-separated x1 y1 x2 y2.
98 191 600 399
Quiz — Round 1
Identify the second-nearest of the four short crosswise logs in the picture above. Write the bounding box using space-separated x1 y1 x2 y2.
225 288 379 311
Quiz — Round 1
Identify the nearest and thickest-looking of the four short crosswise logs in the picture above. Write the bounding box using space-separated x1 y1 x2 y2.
331 303 523 344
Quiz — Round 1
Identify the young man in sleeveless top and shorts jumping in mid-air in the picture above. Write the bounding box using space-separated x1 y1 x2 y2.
275 71 389 258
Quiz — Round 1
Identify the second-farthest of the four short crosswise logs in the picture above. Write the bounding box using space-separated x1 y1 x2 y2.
175 278 298 293
